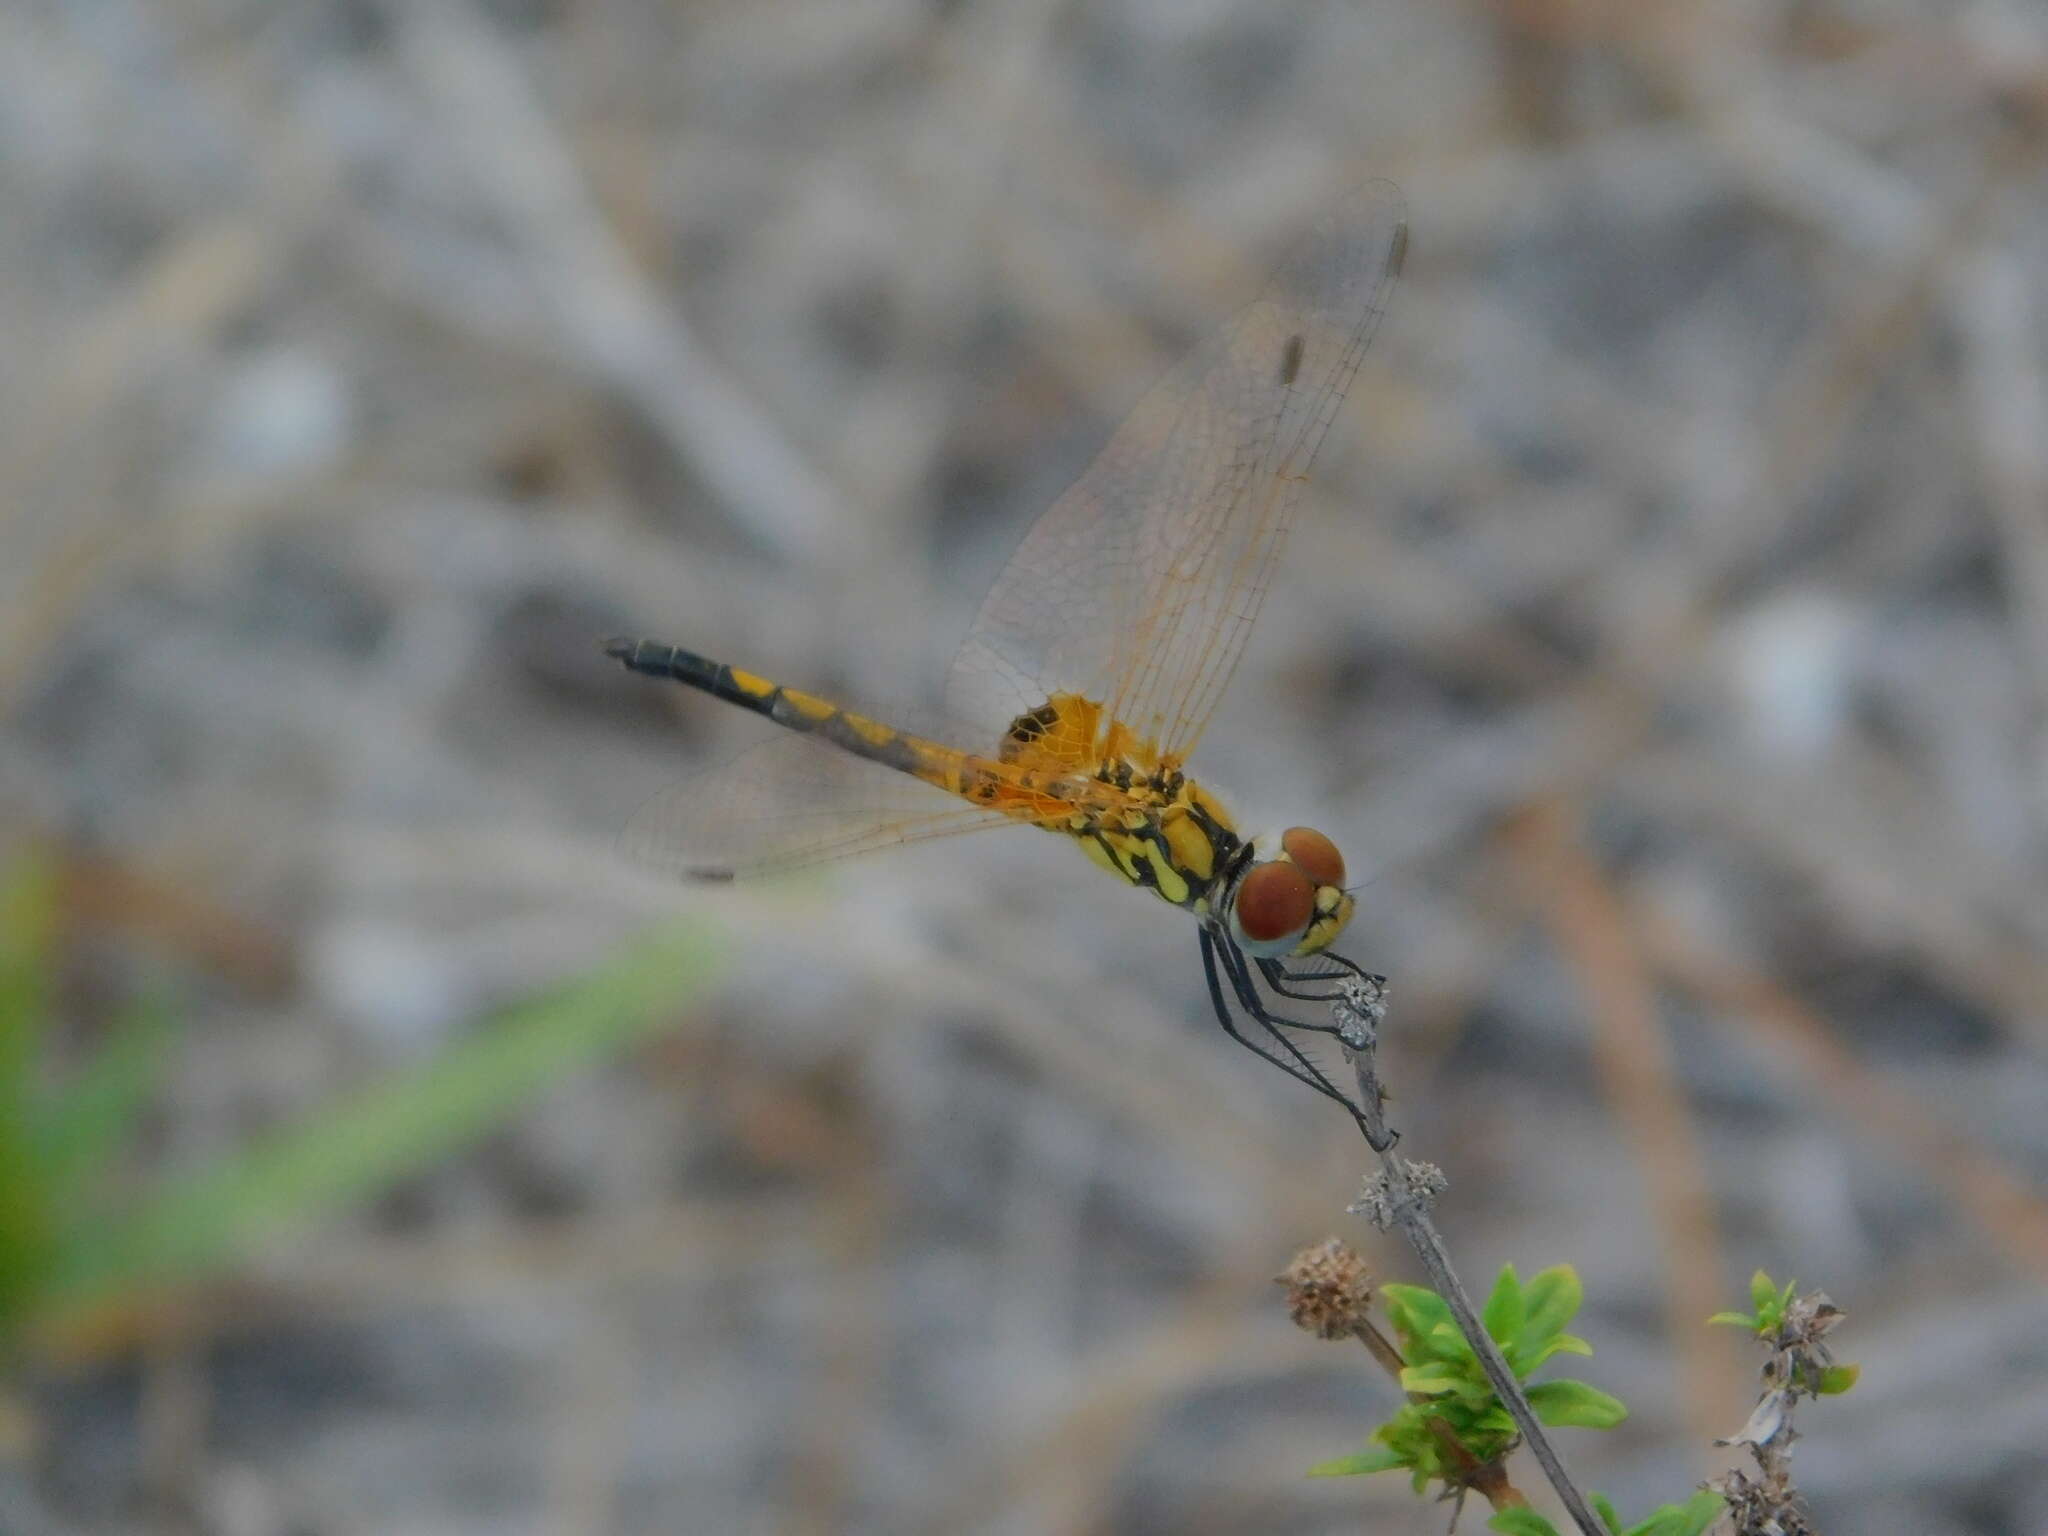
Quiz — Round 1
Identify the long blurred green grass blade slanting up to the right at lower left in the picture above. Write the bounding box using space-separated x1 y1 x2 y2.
59 932 721 1305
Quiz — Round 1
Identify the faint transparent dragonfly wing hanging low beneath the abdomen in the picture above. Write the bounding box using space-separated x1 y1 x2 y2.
618 735 1016 881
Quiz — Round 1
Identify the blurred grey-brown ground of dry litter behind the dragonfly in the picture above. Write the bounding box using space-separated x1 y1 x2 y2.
0 0 2048 1536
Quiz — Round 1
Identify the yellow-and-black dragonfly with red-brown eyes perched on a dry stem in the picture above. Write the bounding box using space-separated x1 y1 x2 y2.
604 182 1407 1135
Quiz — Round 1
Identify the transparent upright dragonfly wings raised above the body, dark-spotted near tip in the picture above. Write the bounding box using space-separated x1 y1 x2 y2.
946 182 1407 758
